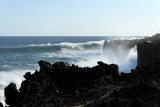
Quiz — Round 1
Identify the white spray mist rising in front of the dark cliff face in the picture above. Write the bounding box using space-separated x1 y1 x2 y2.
104 41 137 72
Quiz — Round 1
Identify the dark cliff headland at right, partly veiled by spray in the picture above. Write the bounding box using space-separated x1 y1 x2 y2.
103 34 160 64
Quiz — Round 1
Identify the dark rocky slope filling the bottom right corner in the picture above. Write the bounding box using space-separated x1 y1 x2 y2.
89 58 160 107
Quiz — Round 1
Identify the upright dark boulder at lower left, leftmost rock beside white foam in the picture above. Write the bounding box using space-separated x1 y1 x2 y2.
4 83 19 106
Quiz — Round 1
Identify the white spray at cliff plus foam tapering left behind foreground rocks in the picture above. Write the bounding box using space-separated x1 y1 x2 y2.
77 46 137 73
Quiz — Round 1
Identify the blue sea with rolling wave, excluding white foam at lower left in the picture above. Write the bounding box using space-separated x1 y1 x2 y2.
0 36 107 72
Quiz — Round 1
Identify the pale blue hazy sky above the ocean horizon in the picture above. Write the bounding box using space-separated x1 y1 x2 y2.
0 0 160 36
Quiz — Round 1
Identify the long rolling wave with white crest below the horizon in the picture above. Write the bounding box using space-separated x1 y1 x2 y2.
0 41 104 53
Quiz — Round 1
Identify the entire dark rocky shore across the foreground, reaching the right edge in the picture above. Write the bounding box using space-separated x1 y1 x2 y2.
2 57 160 107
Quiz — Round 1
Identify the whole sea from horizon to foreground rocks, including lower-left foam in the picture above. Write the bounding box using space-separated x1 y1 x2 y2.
0 36 142 102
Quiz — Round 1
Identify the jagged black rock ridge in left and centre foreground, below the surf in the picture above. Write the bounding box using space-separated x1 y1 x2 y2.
5 60 119 107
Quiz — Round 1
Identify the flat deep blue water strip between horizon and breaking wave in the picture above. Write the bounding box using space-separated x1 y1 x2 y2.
0 36 107 47
